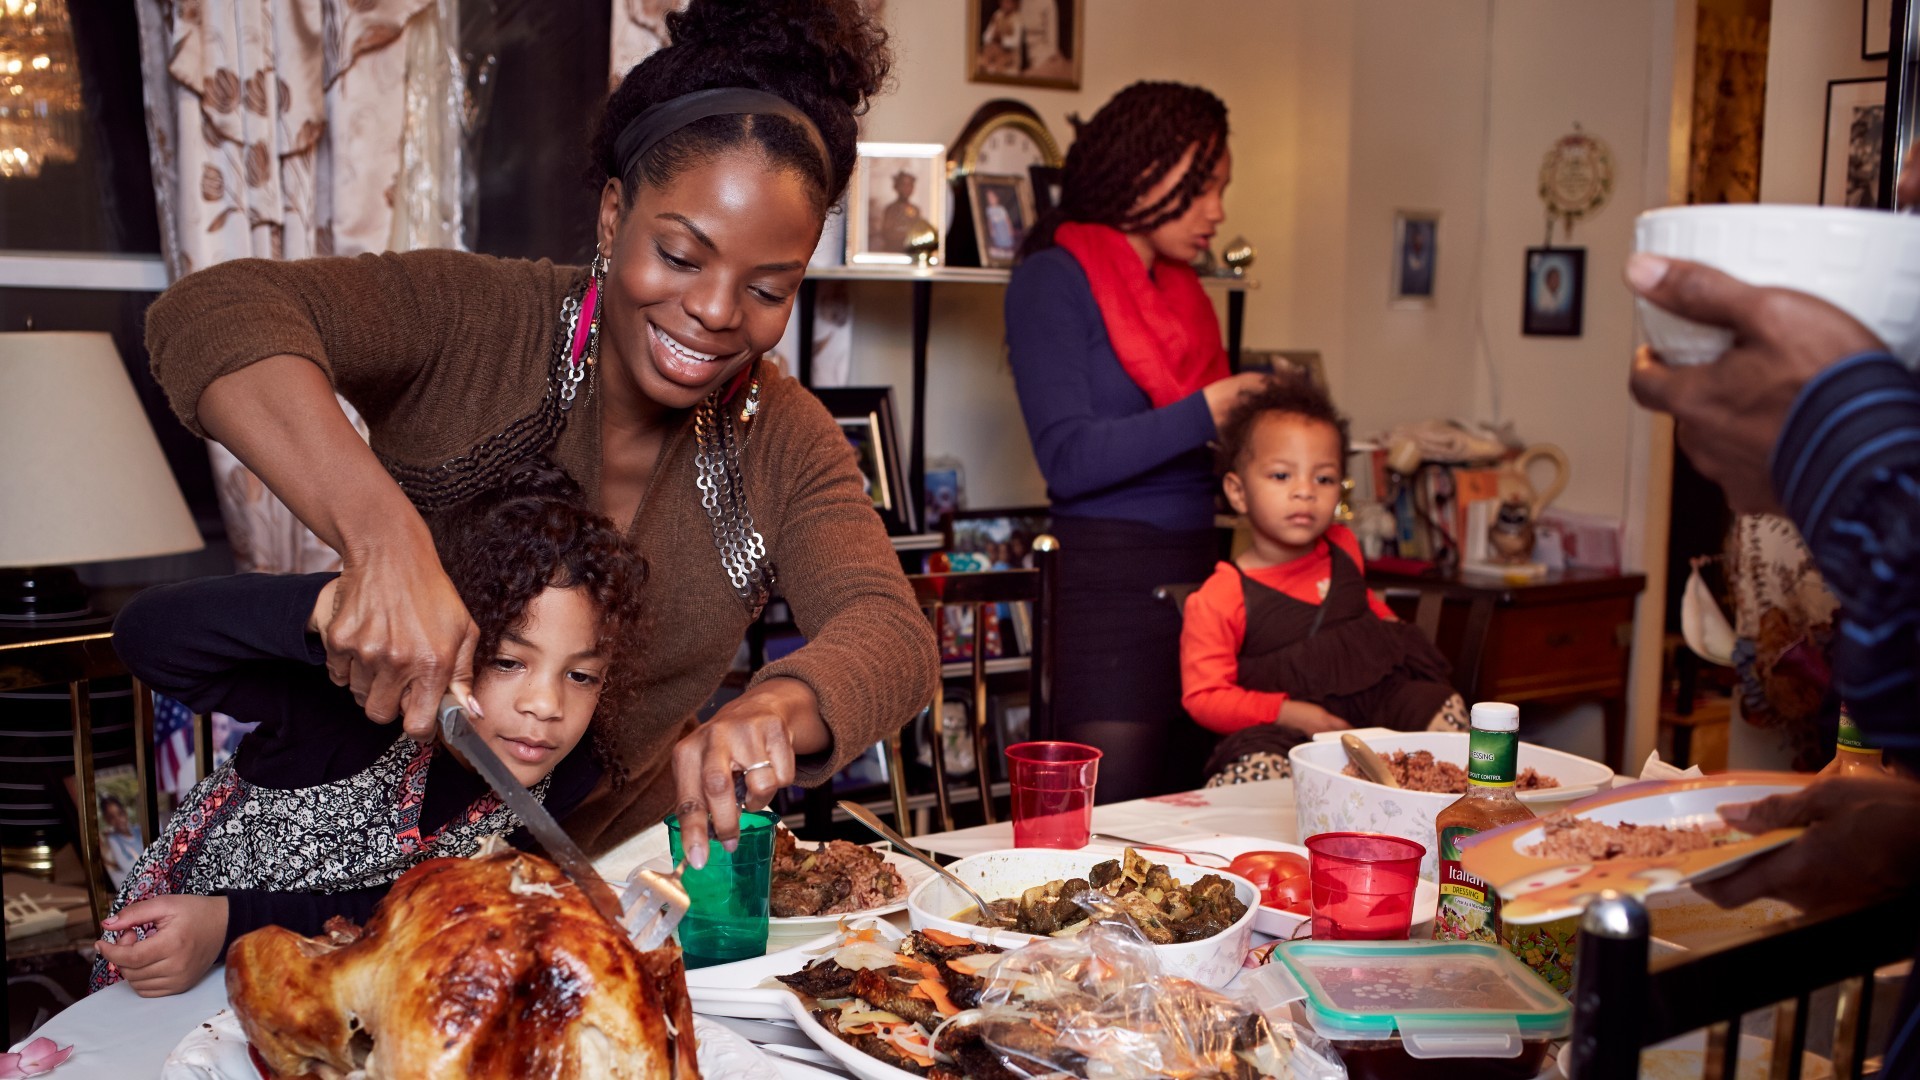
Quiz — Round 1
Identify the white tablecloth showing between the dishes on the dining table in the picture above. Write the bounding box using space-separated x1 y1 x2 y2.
15 780 1298 1080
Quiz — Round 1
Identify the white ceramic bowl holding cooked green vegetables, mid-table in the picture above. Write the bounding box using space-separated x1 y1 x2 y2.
906 847 1260 988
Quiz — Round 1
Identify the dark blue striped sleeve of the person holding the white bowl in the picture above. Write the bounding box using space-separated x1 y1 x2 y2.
1772 354 1920 761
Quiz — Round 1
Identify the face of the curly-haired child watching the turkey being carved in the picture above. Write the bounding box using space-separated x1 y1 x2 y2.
472 588 607 786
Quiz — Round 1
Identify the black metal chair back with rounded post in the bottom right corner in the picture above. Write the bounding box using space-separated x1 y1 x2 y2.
1571 892 1920 1080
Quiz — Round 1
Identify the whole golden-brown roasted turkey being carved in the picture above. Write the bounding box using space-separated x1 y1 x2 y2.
227 851 699 1080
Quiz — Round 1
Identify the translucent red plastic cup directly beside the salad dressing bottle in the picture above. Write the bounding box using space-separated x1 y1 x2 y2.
1308 832 1427 942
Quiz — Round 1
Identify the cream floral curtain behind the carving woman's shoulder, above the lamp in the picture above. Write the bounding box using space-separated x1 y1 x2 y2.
136 0 463 573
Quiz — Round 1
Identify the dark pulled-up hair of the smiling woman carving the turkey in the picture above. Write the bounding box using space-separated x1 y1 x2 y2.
591 0 893 213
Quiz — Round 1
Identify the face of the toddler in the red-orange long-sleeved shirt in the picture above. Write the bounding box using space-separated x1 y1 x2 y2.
1225 413 1342 559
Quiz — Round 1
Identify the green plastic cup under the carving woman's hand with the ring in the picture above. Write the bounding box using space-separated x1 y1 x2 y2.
666 811 776 969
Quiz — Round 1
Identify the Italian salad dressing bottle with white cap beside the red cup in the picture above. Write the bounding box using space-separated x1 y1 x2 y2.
1434 701 1534 944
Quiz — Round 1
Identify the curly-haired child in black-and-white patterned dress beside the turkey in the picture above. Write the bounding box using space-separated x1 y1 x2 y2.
94 459 645 997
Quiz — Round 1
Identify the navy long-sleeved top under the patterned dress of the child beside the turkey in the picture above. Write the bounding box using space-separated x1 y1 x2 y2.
113 575 601 944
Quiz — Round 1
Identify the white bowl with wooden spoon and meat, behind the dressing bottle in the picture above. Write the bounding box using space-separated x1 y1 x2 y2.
1286 728 1613 878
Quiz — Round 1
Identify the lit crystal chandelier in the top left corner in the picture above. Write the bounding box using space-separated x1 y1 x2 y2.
0 0 81 177
